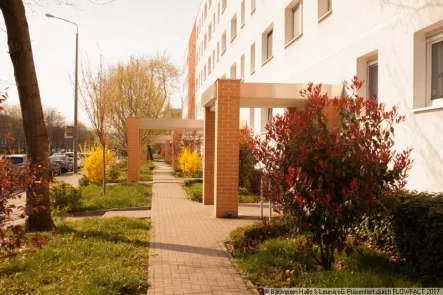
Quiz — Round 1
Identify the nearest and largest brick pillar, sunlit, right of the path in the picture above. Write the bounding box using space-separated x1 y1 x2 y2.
214 79 240 217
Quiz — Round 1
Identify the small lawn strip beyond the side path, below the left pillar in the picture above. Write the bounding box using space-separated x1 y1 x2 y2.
80 183 152 211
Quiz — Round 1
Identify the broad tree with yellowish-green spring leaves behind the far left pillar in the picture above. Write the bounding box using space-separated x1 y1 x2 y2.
107 54 179 155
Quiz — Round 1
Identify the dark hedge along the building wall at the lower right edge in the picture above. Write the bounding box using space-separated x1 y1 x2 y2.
356 191 443 282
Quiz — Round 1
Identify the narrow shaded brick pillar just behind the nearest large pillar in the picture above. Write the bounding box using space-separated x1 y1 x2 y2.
203 108 215 205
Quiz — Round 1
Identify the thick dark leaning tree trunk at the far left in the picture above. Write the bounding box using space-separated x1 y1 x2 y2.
0 0 55 231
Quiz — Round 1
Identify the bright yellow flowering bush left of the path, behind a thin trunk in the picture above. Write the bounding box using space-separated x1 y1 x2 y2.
82 143 114 184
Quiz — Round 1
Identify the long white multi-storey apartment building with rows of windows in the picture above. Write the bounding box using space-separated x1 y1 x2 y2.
186 0 443 191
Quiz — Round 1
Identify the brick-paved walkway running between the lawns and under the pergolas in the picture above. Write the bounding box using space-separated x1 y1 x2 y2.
148 162 259 295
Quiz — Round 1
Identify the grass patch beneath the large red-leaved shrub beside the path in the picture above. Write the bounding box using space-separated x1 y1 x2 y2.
237 237 421 288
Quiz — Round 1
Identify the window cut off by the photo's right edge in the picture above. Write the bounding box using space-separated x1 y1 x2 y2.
426 32 443 105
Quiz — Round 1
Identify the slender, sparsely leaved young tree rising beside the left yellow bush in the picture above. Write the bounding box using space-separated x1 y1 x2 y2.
79 57 114 195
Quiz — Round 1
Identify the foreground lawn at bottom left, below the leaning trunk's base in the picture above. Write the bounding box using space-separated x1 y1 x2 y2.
0 217 150 295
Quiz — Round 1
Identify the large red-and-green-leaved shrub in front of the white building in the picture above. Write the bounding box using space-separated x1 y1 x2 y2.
257 78 412 269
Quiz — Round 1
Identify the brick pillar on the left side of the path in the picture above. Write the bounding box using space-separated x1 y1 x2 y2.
128 118 140 182
